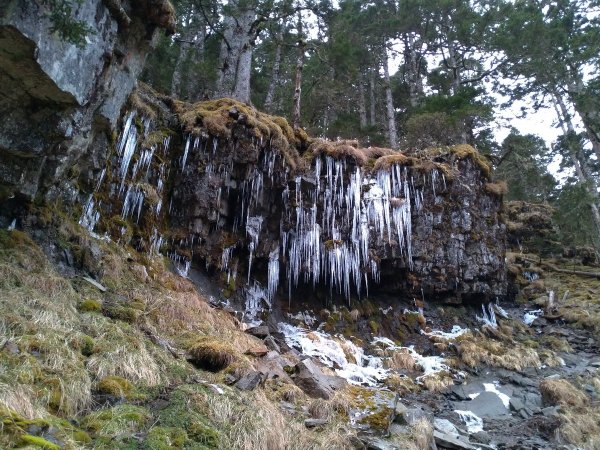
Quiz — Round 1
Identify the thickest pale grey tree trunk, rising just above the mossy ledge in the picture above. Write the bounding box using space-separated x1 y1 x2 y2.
217 7 256 103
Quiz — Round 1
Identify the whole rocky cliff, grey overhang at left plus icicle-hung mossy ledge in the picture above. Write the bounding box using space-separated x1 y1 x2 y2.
0 0 506 309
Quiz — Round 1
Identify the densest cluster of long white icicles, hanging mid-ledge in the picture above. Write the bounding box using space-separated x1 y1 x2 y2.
281 156 445 298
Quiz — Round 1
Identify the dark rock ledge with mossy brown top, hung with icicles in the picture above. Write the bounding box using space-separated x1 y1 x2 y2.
83 91 506 309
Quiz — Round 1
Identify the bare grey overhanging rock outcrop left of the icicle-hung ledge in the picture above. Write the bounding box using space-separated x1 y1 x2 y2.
0 0 174 202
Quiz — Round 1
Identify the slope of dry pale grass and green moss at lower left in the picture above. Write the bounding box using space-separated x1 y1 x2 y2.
0 227 364 449
